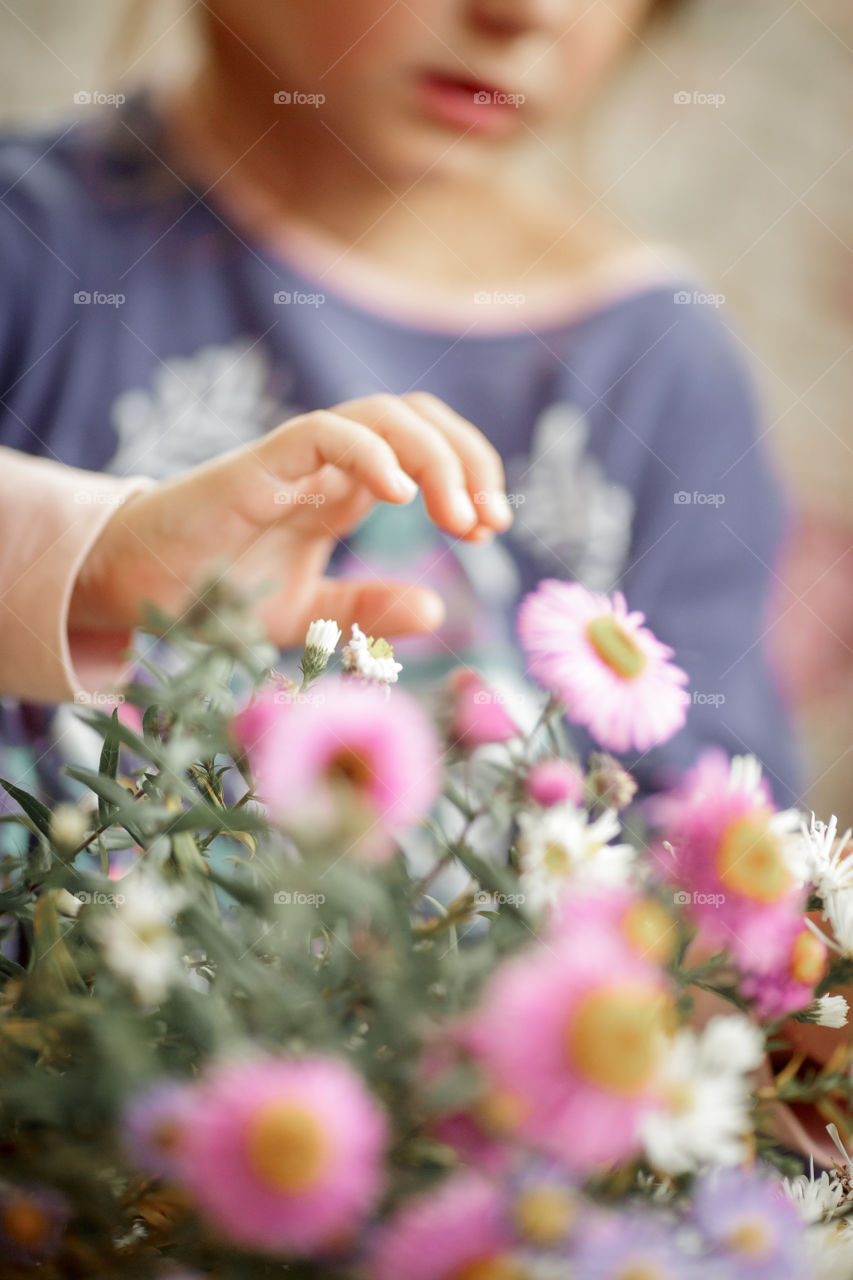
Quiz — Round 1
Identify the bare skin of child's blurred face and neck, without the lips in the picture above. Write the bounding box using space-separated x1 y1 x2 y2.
163 0 651 296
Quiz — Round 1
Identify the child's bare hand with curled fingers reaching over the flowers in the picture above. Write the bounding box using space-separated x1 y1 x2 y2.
69 393 512 646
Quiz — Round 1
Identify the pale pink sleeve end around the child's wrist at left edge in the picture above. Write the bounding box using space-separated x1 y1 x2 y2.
0 448 152 703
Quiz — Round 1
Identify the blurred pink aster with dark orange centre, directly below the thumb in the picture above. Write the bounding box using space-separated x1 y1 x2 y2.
234 680 441 860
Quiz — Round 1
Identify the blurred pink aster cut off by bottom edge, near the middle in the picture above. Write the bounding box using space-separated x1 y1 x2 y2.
368 1174 516 1280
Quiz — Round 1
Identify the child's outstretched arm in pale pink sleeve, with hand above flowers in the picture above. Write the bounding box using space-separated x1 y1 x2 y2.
0 394 511 701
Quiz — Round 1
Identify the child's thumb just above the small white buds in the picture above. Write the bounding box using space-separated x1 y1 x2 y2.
268 579 446 648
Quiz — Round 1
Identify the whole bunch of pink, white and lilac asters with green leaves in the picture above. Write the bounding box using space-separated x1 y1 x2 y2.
0 582 853 1280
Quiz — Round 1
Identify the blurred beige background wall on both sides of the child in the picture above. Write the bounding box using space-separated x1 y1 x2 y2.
0 0 853 826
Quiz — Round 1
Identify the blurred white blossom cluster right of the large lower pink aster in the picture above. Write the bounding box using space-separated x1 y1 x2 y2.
640 1015 761 1174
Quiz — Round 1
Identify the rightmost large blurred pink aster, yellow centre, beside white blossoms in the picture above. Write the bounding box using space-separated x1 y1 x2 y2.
660 748 806 972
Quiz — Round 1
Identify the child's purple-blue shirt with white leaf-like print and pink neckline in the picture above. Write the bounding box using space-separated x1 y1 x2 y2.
0 99 798 803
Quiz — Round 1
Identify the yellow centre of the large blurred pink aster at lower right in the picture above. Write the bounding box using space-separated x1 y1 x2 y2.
566 982 666 1097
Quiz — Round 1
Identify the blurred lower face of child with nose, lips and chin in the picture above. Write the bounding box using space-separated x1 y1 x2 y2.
206 0 651 180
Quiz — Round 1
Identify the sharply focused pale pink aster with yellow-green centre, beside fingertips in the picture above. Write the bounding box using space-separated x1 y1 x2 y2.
519 579 689 751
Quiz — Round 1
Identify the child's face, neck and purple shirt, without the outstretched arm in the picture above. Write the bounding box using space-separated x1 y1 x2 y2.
0 0 797 800
